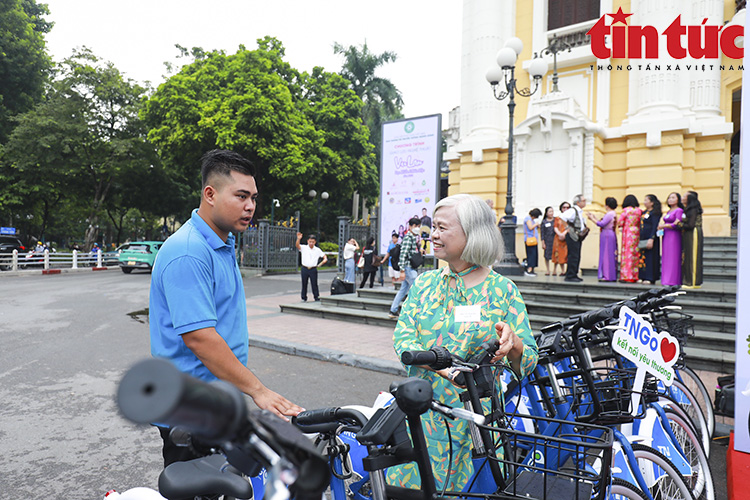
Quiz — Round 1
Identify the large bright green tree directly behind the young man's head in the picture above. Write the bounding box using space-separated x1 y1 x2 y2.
143 37 377 235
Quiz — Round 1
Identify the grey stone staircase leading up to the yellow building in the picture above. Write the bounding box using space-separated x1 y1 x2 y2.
281 238 737 373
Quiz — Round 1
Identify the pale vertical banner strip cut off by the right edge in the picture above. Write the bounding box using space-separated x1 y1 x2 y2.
734 16 750 453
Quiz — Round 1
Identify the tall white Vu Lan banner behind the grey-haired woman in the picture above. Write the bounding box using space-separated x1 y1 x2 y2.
379 115 443 255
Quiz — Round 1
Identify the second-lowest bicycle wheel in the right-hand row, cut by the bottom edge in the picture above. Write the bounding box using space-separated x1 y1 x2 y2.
632 444 695 500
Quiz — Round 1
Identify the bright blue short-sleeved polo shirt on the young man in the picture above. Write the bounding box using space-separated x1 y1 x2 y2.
149 209 248 381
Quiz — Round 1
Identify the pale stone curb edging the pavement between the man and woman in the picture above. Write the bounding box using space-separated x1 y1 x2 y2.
250 335 406 377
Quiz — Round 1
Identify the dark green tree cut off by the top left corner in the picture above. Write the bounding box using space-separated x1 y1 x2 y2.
0 0 52 144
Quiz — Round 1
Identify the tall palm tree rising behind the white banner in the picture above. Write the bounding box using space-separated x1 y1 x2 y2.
333 43 404 159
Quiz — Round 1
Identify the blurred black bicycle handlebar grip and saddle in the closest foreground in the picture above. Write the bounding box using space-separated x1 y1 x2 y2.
117 359 328 500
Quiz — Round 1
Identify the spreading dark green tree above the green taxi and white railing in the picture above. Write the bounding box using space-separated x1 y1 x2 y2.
0 49 156 248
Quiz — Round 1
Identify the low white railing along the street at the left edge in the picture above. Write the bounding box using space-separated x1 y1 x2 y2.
0 250 119 271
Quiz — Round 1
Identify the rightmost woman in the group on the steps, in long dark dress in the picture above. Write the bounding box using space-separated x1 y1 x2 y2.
680 191 703 288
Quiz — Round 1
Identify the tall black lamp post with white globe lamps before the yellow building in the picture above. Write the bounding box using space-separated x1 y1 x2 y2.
486 37 547 275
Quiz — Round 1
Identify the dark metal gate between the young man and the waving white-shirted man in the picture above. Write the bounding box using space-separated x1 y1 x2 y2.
239 212 299 271
